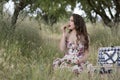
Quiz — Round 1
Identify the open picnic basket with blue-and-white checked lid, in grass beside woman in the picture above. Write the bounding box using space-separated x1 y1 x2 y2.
98 46 120 74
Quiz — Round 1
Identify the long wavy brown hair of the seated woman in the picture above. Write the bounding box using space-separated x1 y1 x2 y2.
72 14 89 50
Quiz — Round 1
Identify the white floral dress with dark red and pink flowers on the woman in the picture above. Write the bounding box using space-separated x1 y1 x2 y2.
53 42 93 73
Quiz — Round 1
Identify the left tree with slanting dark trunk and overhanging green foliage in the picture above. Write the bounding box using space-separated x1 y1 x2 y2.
11 0 76 29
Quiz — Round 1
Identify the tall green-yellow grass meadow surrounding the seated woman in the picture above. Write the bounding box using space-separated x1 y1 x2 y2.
0 15 120 80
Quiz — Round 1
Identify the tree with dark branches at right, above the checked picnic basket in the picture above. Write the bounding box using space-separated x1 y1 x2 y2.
78 0 120 32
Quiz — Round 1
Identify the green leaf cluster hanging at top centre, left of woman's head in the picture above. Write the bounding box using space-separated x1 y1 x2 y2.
34 0 75 25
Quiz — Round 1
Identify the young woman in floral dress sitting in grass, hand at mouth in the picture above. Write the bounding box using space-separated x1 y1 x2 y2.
53 14 89 73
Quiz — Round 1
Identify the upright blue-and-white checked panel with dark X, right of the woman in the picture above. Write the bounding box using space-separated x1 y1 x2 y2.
98 46 120 66
